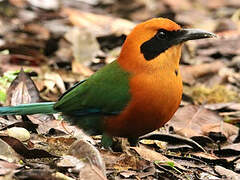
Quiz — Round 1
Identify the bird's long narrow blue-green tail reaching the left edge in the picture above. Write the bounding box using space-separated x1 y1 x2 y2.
0 102 58 116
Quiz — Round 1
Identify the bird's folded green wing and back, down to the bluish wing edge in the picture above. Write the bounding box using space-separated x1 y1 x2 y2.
54 61 130 113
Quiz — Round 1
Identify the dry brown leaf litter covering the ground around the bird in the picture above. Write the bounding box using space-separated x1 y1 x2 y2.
0 0 240 179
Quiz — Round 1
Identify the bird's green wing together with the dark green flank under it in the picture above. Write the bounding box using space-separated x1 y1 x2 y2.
54 61 131 131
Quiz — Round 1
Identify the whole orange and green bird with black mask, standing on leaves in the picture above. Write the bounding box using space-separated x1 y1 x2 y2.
0 17 216 147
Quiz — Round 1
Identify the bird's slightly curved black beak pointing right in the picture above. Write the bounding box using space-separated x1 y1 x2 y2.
177 29 217 43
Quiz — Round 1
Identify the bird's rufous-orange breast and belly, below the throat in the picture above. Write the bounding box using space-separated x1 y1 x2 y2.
105 71 182 137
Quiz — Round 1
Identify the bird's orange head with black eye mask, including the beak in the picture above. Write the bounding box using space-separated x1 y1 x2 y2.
119 18 215 72
